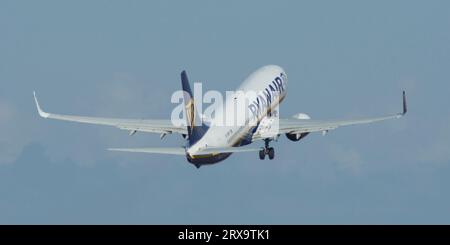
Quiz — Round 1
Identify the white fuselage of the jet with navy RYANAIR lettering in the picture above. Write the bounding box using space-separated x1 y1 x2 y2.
187 65 287 156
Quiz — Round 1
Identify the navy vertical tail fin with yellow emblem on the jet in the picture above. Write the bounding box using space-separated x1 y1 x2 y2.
181 71 206 145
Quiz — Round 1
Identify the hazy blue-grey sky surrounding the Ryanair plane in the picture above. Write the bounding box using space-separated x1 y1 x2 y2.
0 0 450 224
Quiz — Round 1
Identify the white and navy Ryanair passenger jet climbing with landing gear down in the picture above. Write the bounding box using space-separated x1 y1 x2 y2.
33 65 407 168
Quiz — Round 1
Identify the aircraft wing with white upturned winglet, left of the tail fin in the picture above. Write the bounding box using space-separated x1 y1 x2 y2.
33 92 187 134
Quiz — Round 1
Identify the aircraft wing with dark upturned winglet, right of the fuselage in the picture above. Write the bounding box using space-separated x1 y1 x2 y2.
254 91 407 139
